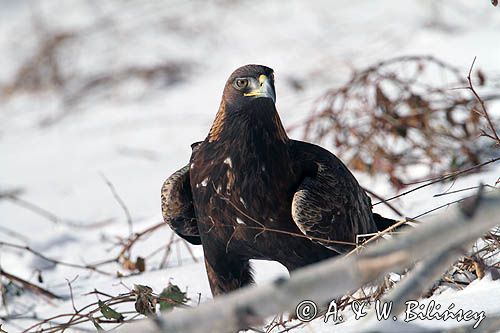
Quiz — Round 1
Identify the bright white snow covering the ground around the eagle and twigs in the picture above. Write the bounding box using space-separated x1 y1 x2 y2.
0 0 500 332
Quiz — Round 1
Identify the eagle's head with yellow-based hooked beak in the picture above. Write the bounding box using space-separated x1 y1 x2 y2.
223 65 276 107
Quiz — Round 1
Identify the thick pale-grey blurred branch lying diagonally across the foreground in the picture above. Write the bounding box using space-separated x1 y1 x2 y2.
123 191 500 333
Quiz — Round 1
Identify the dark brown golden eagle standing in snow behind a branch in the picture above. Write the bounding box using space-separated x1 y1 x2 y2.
161 65 391 295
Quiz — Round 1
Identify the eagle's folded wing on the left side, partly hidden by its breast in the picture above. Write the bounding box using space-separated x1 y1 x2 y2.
161 143 201 245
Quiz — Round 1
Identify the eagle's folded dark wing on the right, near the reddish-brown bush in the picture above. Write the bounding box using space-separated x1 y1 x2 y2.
290 140 377 253
